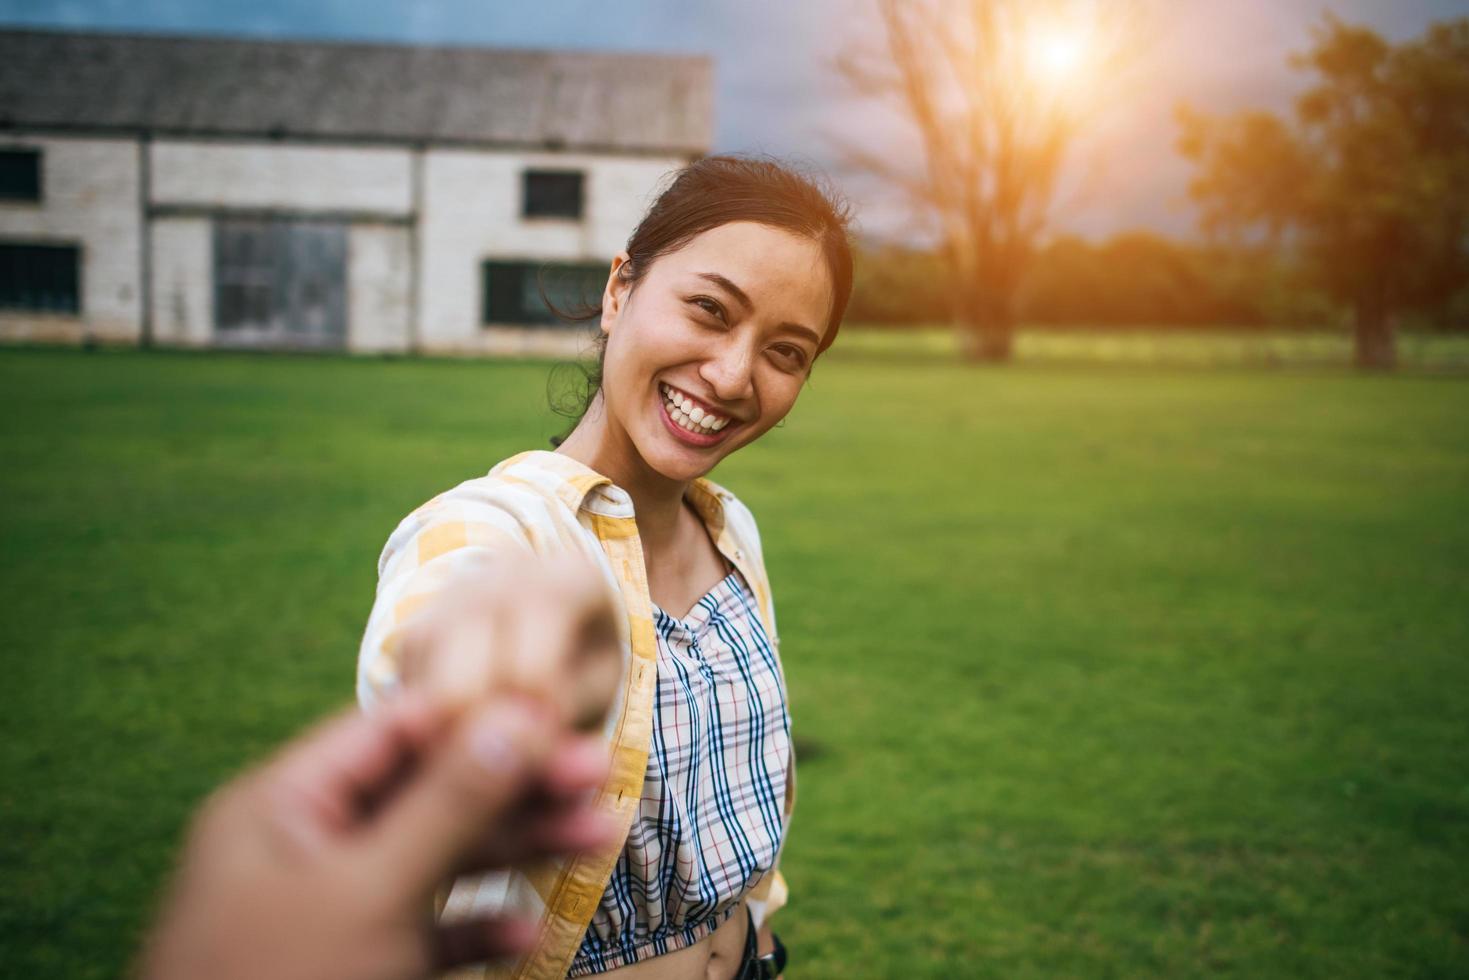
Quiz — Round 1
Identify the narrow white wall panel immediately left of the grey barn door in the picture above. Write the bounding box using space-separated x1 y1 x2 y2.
151 217 214 347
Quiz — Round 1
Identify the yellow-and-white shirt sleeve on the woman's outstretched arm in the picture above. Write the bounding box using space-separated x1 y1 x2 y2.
357 491 533 711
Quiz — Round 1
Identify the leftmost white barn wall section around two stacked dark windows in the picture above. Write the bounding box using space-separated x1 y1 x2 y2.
0 134 142 341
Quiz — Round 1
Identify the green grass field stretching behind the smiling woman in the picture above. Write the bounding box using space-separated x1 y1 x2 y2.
0 344 1469 980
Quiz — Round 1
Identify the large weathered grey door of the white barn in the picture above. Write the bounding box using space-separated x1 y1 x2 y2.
214 217 347 350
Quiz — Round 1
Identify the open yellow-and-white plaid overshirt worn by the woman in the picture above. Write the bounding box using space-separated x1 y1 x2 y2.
357 450 796 980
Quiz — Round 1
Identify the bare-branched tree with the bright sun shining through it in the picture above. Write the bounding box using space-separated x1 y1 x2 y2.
837 0 1140 360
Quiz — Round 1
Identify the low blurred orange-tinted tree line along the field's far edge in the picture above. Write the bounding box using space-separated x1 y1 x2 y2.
848 231 1469 332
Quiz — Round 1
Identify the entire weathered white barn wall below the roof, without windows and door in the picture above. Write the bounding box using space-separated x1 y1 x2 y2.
0 134 683 356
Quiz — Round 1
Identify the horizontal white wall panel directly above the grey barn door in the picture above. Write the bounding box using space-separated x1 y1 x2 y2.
151 141 413 217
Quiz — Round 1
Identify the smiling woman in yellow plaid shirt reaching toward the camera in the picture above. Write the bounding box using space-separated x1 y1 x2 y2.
358 157 852 980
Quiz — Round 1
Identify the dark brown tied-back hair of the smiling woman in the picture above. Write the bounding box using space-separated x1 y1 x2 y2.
548 156 852 447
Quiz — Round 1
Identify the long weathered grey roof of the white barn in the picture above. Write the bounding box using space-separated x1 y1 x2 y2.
0 31 712 154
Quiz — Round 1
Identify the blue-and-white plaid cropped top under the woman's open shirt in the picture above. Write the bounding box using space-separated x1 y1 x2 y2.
567 570 790 977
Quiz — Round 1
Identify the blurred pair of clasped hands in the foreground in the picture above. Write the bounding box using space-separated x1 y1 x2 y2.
141 552 617 980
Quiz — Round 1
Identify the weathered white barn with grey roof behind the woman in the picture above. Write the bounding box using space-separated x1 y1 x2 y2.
0 31 712 354
